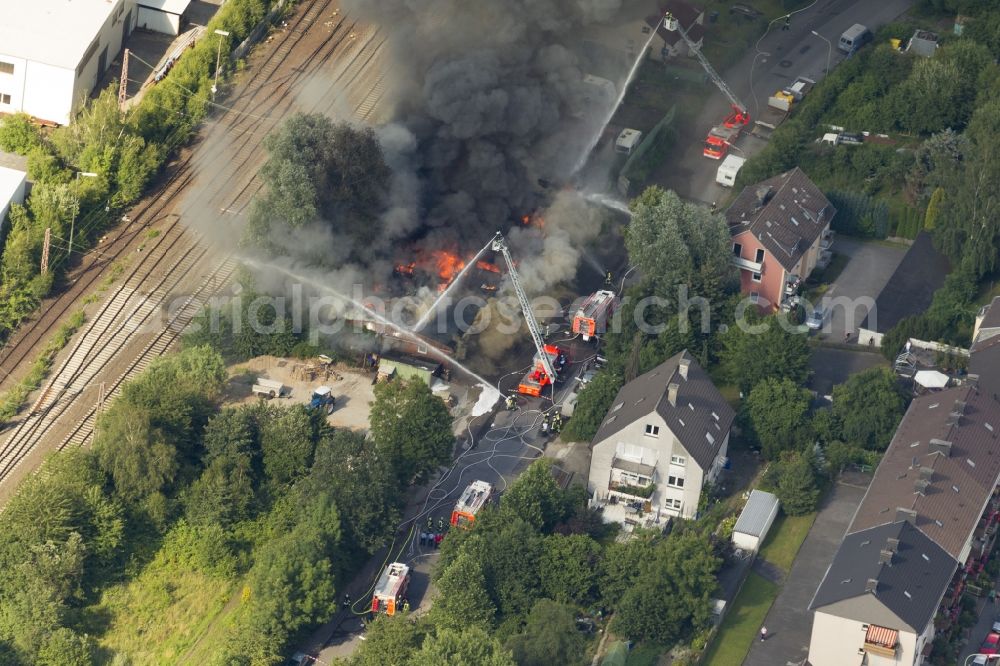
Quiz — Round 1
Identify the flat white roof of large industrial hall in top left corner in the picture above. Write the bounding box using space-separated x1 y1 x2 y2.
0 0 125 70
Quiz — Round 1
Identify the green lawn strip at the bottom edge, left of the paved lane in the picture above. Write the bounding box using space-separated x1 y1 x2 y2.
701 571 778 666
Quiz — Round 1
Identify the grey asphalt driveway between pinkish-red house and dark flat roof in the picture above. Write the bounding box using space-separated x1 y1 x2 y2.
819 237 909 342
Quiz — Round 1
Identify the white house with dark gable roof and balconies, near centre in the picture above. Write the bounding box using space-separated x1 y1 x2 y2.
587 350 734 525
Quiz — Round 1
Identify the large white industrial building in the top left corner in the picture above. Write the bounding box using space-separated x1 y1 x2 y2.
0 0 137 125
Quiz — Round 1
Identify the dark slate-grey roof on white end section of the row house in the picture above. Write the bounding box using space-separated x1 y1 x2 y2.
809 521 958 633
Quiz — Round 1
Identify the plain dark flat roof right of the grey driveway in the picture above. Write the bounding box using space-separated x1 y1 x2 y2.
861 232 951 333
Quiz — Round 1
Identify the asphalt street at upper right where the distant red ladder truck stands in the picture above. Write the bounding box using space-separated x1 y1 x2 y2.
654 0 912 203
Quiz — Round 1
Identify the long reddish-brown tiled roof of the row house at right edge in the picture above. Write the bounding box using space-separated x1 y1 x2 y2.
848 385 1000 560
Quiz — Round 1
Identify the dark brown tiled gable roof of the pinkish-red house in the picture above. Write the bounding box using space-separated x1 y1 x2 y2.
726 167 837 272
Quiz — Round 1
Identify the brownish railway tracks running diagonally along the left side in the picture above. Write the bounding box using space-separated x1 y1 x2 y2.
0 0 394 496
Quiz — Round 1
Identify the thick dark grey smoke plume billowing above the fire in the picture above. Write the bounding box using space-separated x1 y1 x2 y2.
345 0 625 252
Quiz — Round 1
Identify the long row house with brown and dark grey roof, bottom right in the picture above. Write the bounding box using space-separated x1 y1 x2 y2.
809 382 1000 666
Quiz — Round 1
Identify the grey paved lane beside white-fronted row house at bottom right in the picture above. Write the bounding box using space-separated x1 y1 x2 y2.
743 475 870 666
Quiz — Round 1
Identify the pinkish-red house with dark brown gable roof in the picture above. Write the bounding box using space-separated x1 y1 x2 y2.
726 167 837 311
